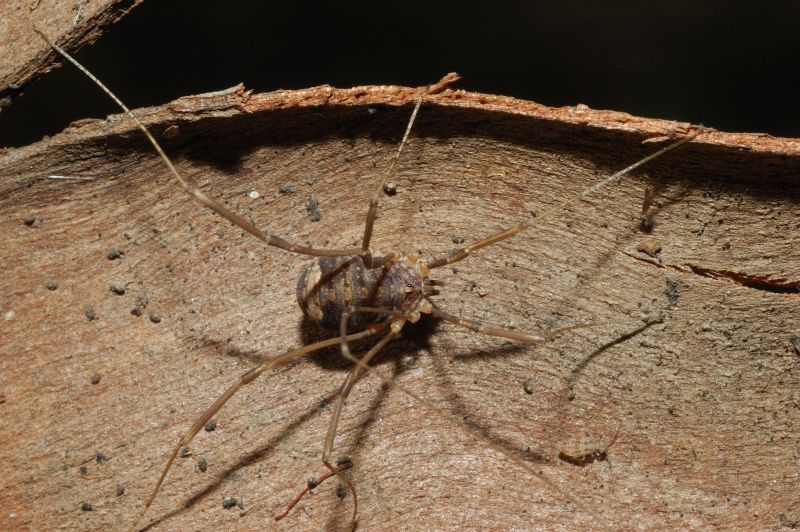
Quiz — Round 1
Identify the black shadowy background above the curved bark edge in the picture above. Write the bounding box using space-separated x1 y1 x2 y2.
0 0 800 146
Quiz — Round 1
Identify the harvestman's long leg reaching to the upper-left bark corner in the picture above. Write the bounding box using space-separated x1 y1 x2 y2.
34 29 361 257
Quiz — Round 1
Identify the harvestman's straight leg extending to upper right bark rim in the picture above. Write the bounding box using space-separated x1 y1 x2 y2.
428 128 703 268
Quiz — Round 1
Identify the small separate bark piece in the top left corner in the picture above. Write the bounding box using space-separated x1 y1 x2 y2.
0 0 142 109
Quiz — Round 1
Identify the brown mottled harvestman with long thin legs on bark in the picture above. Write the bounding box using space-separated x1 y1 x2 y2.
35 30 701 529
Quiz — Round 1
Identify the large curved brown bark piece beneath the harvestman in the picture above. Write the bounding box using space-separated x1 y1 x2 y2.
0 82 800 530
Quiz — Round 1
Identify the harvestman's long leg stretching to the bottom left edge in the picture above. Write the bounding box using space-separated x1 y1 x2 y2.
130 324 386 530
